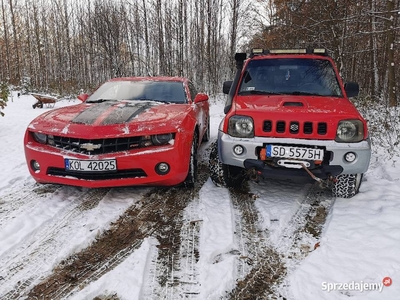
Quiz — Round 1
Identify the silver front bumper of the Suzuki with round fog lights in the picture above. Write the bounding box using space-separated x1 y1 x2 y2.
218 131 371 179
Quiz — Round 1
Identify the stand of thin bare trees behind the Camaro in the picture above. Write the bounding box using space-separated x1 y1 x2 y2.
0 0 251 93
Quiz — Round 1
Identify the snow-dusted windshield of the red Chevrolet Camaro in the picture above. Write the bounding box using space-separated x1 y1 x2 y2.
86 80 187 103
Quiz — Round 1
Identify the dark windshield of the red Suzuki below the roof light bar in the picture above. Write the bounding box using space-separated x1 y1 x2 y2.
239 58 342 97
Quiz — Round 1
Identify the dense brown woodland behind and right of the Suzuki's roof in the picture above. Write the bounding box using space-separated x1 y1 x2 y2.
249 0 400 105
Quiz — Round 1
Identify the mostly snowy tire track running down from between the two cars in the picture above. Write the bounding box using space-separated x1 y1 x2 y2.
144 164 208 300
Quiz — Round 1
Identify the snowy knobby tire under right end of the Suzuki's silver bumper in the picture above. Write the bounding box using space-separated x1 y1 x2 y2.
332 174 363 198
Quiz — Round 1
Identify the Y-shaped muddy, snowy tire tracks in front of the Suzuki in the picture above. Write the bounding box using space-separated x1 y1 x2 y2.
228 183 333 299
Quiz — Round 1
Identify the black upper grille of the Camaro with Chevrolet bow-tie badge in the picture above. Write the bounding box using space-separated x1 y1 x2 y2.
51 136 150 155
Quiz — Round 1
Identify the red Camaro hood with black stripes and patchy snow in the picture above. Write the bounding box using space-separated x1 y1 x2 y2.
29 101 190 138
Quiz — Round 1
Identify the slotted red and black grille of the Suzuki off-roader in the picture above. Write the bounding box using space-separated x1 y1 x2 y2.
263 120 328 135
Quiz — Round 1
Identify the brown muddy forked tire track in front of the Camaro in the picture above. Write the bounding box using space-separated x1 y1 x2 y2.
27 175 206 299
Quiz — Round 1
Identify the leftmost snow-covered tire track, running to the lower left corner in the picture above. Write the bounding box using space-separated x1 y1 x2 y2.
0 187 110 299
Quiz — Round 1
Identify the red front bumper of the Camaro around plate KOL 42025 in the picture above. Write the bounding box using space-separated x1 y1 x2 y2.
25 137 191 188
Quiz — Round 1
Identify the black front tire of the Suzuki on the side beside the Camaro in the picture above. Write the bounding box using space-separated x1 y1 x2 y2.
208 141 246 187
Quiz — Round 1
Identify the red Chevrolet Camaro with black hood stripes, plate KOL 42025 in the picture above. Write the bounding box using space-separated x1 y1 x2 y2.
24 77 210 188
